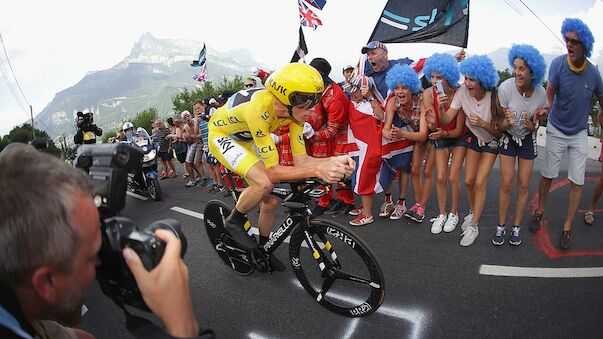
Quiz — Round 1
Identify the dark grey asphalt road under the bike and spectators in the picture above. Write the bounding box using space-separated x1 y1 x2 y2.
81 152 603 338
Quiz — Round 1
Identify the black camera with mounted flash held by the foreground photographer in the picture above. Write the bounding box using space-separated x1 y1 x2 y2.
75 143 187 311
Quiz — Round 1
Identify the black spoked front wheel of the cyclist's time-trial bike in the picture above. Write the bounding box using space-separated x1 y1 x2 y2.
289 219 385 317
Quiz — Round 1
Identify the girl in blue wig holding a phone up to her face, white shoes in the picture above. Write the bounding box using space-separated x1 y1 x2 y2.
420 53 467 234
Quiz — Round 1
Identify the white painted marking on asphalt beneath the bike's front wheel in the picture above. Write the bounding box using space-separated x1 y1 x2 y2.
291 280 427 338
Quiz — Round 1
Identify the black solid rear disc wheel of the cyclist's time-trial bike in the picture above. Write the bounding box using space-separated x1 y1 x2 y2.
203 200 254 275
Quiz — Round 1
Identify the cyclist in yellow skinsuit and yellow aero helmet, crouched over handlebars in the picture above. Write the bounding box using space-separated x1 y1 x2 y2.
208 63 355 270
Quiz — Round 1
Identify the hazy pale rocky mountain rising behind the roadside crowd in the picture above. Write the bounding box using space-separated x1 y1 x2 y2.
35 33 260 140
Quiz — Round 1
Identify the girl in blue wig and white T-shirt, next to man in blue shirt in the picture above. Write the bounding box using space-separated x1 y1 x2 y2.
492 45 548 246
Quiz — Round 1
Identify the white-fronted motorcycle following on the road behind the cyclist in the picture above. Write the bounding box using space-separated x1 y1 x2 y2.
125 127 161 201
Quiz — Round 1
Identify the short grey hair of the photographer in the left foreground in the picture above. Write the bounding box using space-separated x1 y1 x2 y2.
0 145 92 283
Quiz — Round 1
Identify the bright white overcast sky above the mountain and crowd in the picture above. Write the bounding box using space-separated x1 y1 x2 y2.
0 0 603 137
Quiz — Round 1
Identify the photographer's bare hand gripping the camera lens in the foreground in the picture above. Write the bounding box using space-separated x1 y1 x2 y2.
123 230 199 337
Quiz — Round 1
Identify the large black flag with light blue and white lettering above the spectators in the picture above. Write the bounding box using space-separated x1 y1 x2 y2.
369 0 469 47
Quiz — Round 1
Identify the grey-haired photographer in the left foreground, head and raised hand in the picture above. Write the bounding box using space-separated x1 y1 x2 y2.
0 145 211 338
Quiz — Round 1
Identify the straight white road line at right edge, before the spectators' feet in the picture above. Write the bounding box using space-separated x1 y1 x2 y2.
479 265 603 278
